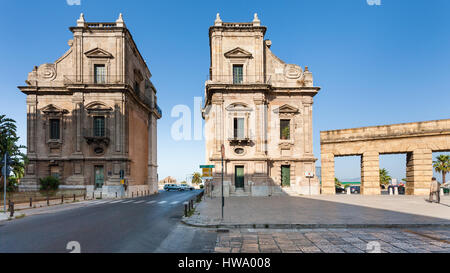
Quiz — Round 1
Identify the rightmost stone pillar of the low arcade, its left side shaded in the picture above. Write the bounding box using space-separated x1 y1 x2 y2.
406 149 433 195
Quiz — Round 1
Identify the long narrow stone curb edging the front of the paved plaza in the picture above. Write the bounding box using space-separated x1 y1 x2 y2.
181 217 450 229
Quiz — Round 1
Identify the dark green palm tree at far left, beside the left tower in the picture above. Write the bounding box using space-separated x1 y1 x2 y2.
0 115 27 191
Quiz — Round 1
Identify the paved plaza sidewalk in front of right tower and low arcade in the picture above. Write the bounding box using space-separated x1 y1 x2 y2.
182 195 450 229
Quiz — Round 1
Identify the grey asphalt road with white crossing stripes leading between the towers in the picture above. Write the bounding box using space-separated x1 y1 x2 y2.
0 190 217 253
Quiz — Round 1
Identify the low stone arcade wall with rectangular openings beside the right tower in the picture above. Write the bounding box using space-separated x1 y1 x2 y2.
320 119 450 195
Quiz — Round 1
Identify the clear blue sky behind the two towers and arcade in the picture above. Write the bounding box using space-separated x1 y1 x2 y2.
0 0 450 182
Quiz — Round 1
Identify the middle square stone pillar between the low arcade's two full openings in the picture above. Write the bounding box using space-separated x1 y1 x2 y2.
361 151 381 195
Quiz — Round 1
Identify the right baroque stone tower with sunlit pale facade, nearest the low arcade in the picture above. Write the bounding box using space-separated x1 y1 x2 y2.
203 14 320 196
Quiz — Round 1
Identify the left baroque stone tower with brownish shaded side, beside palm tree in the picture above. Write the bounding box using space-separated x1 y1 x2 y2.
18 14 161 196
